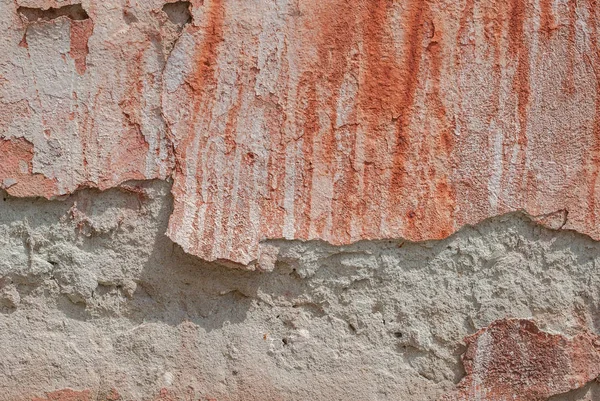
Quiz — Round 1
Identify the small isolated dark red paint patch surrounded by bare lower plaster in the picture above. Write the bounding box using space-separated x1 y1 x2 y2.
440 319 600 401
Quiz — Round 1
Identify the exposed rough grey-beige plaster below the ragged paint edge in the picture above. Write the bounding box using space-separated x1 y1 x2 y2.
0 181 600 401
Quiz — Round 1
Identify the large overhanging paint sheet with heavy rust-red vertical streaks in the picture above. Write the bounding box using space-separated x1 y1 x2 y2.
163 0 600 264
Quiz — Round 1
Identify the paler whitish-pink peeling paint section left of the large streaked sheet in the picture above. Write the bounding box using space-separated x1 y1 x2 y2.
0 1 172 198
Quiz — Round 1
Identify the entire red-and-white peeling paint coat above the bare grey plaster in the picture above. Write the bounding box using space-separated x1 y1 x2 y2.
0 0 600 265
